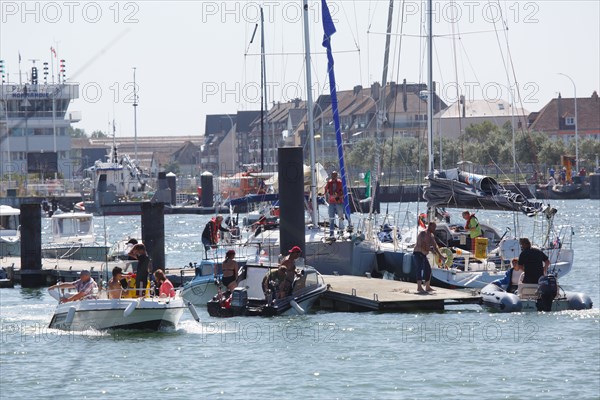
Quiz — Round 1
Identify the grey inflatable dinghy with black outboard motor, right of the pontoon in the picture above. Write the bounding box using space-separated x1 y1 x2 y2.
481 275 592 312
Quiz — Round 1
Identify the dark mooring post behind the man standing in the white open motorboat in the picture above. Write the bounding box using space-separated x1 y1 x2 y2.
142 201 166 270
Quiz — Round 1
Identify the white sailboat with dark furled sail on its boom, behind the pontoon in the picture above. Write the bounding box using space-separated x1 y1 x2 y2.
382 1 573 288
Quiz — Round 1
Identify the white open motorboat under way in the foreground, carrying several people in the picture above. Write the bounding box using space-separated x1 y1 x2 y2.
49 289 190 331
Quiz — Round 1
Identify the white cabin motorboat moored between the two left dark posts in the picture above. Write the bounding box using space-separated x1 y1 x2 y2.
42 212 110 261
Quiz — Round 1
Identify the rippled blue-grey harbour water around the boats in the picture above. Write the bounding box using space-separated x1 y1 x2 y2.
0 200 600 399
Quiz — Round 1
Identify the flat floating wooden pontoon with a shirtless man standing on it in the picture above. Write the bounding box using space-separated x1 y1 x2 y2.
320 275 481 312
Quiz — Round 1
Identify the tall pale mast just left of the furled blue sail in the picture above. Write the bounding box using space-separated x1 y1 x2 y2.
302 0 318 226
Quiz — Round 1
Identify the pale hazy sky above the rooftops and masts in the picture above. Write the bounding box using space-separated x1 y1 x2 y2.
0 0 600 136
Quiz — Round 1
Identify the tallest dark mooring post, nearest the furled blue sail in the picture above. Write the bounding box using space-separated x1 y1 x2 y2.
278 147 306 257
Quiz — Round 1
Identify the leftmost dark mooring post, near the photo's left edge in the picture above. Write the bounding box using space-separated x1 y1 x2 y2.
21 203 46 288
